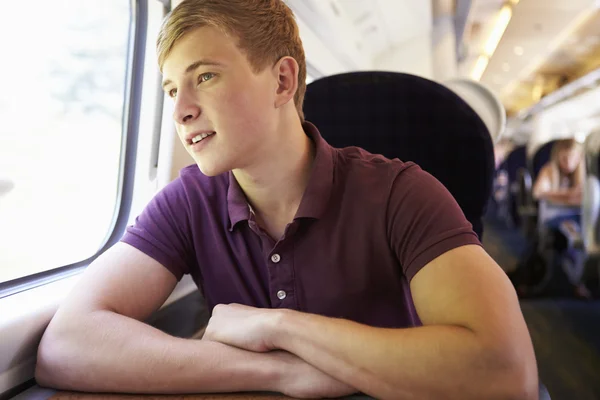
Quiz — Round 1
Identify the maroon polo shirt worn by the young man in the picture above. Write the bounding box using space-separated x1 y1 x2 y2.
122 123 480 327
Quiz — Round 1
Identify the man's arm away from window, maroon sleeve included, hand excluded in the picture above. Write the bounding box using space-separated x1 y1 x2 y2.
262 168 537 399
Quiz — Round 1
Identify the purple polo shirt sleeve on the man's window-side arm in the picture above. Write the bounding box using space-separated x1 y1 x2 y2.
121 178 193 280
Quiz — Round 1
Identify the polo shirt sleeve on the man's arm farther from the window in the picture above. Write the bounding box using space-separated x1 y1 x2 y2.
387 164 481 282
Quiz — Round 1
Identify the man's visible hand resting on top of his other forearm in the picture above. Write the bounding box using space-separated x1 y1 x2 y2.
203 304 281 353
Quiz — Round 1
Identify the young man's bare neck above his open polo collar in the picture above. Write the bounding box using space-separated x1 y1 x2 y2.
233 120 315 239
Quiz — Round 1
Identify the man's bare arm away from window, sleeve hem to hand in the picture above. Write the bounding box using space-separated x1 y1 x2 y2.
206 245 538 400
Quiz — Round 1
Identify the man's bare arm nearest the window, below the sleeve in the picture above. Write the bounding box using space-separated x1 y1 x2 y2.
36 243 355 397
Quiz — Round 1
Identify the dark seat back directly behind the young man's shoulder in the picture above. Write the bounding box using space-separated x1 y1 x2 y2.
304 72 494 238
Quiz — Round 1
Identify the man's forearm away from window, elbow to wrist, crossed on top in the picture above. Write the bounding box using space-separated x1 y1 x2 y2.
273 311 537 399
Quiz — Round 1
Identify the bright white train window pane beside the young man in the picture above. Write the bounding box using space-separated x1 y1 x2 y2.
0 0 132 284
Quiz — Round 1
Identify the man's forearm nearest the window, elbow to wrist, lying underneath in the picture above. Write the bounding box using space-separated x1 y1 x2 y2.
36 311 281 393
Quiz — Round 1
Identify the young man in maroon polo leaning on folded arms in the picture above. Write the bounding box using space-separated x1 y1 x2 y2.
36 0 537 399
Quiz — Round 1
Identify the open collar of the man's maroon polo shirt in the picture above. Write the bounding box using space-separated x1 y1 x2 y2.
227 122 334 231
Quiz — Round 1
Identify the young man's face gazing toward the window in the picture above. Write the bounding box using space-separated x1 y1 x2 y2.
163 27 277 176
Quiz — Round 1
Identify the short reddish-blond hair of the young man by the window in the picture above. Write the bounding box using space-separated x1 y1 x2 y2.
156 0 306 121
